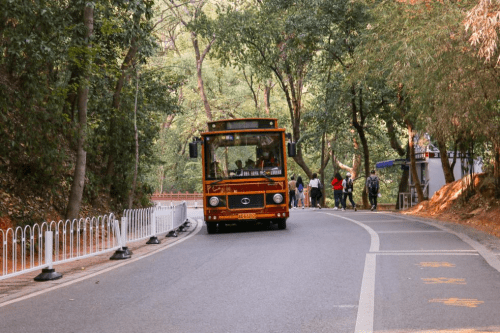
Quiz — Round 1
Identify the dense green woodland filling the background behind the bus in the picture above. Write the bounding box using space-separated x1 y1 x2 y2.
0 0 500 223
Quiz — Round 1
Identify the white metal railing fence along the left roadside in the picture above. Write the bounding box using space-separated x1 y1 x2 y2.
0 202 203 280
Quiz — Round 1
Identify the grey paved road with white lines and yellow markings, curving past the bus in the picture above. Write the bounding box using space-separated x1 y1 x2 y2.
0 209 500 333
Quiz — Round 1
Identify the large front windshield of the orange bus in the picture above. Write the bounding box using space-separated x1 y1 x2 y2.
204 132 284 179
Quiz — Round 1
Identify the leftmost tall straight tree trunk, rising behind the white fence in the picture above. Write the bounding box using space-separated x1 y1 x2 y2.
66 6 94 220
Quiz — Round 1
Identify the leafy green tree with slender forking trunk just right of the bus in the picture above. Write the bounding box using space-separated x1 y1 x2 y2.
202 0 364 177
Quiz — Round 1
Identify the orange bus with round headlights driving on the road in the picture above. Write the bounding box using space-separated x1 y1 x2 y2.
189 118 296 233
